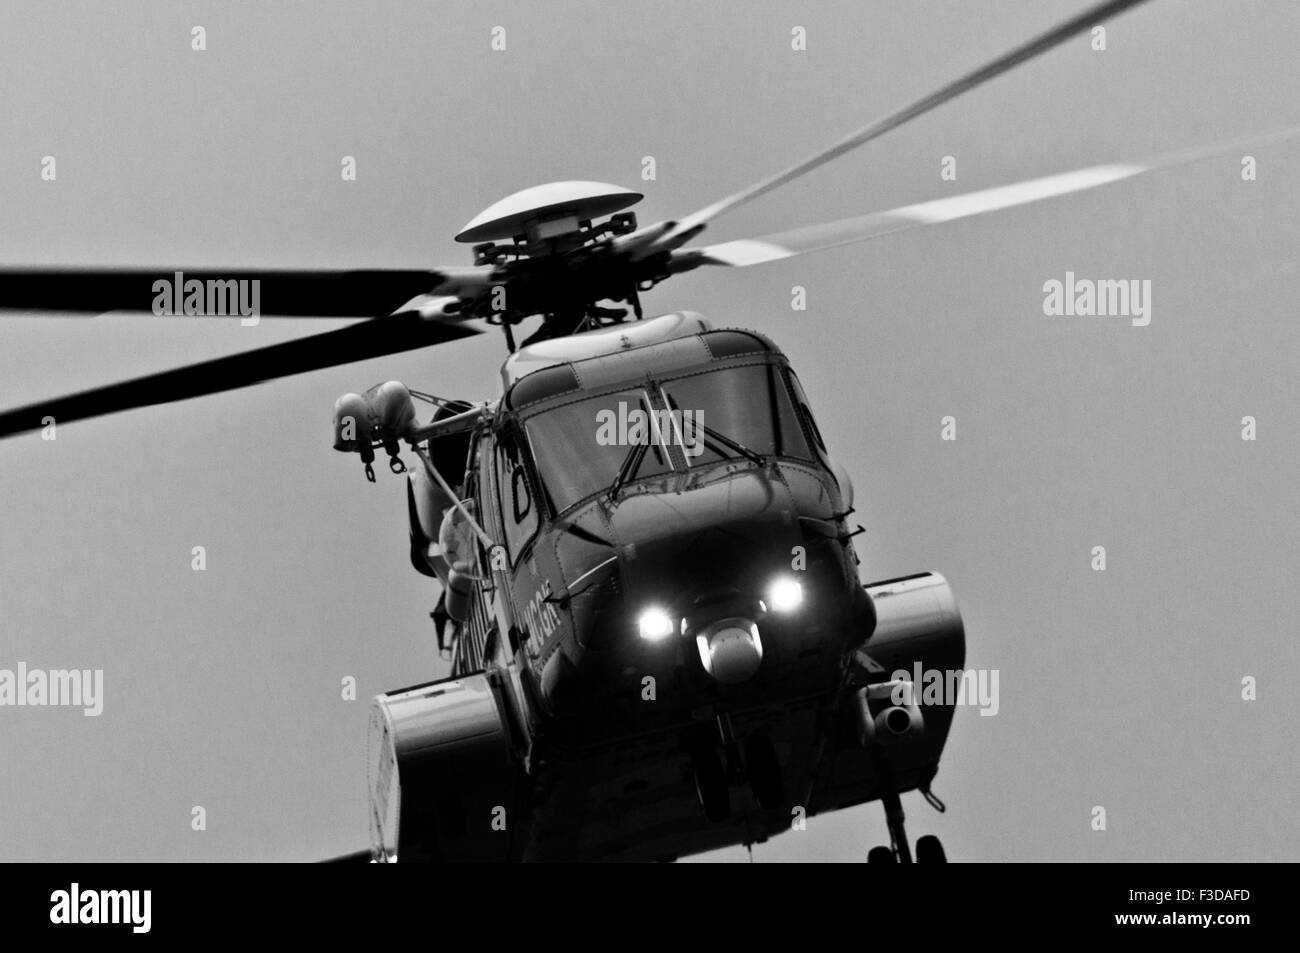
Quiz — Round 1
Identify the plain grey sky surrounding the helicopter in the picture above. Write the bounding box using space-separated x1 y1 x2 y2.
0 0 1300 861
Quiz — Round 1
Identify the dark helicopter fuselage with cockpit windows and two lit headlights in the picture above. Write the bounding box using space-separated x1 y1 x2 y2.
372 313 961 859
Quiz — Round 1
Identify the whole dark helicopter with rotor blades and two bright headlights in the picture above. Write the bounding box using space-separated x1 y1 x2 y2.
0 3 1294 861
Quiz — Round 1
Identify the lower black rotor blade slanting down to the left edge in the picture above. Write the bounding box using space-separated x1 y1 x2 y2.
0 298 478 437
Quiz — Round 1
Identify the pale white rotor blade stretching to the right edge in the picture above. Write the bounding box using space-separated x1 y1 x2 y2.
668 126 1300 273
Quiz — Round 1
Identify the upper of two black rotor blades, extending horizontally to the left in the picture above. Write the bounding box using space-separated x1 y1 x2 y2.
0 267 491 317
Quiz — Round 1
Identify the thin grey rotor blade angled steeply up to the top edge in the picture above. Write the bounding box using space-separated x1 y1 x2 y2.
637 0 1147 257
